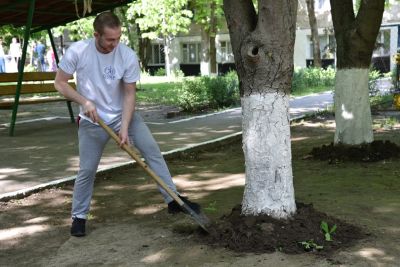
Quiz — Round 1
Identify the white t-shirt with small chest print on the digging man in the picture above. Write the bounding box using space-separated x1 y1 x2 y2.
59 38 140 124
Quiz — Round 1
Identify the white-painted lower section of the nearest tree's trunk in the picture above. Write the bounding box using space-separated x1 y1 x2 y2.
241 92 296 219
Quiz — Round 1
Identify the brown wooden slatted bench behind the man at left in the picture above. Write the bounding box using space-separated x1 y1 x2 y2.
0 72 76 135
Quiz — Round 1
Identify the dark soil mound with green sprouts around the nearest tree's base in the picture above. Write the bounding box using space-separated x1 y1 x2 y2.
202 203 369 256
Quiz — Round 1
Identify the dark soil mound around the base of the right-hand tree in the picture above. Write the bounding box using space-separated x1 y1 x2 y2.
310 140 400 163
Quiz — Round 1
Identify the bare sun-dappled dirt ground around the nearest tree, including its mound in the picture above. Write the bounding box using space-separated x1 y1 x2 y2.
0 109 400 266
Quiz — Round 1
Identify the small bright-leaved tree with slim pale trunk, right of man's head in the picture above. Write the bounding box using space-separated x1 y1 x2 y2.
127 0 193 76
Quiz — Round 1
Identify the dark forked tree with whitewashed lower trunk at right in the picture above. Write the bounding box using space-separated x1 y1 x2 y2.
330 0 385 145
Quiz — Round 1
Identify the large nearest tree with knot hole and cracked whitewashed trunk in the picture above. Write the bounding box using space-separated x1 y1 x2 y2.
224 0 297 219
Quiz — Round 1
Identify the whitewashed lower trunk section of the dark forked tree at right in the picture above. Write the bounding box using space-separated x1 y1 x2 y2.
334 69 374 145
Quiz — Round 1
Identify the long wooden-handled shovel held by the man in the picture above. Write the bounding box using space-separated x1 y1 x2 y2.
97 119 210 233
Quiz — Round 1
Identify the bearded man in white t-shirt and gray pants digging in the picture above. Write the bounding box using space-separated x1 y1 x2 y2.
55 12 200 236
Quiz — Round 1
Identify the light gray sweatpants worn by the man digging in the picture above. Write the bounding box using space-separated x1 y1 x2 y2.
72 112 177 219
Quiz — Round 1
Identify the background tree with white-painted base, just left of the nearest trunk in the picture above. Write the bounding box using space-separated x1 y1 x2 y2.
191 0 225 75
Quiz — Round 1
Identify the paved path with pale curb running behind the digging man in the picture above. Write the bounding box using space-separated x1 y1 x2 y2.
0 92 332 200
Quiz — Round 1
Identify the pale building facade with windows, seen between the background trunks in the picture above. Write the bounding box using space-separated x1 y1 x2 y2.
148 0 400 76
